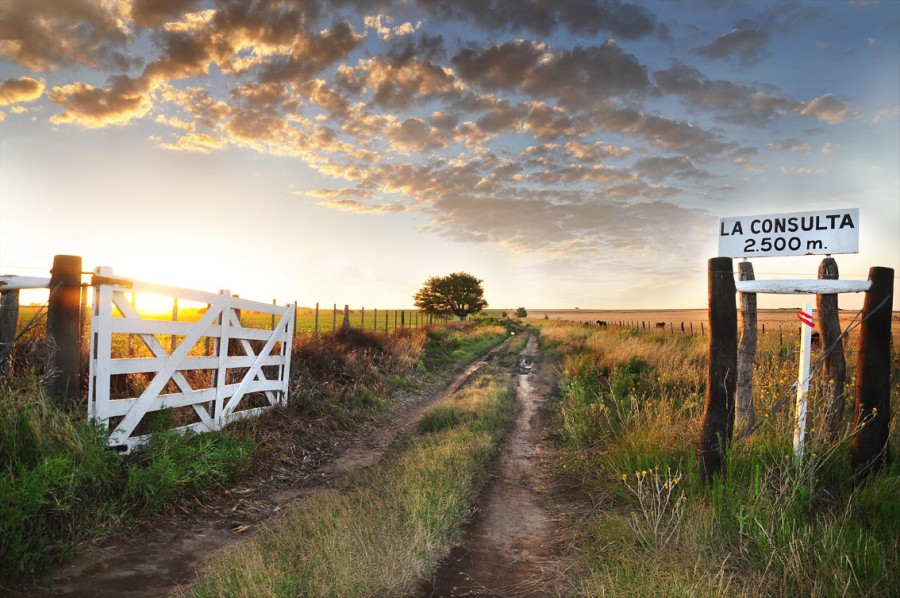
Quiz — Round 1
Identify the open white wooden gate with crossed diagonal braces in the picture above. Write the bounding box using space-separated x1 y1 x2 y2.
88 267 296 452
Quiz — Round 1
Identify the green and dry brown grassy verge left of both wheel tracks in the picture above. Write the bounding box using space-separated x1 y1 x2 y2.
0 324 506 582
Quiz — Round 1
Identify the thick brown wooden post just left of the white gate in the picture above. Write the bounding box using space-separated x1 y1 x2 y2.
47 255 81 404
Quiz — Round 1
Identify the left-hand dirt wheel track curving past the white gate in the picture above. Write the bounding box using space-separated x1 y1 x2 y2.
17 341 508 598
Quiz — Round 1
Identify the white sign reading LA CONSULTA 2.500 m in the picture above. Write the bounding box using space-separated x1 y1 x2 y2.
719 208 859 257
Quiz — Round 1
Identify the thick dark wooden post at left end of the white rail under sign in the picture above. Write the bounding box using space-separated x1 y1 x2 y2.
697 257 737 480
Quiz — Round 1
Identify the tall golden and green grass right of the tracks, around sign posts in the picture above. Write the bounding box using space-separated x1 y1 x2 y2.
541 325 900 596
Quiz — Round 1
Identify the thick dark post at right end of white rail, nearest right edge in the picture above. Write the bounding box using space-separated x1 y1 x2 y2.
851 267 894 476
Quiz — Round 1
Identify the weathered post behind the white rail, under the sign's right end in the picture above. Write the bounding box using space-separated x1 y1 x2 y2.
816 256 847 440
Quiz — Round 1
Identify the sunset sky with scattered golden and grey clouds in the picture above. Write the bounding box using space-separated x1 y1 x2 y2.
0 0 900 309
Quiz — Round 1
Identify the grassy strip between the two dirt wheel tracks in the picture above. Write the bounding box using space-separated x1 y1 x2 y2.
188 358 514 596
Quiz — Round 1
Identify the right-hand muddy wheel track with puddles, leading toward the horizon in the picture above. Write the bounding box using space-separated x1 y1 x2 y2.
421 335 557 598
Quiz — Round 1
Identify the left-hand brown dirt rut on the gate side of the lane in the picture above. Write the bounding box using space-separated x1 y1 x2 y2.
15 338 511 598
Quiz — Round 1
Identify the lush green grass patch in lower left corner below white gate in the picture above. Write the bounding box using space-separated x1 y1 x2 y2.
0 375 252 579
